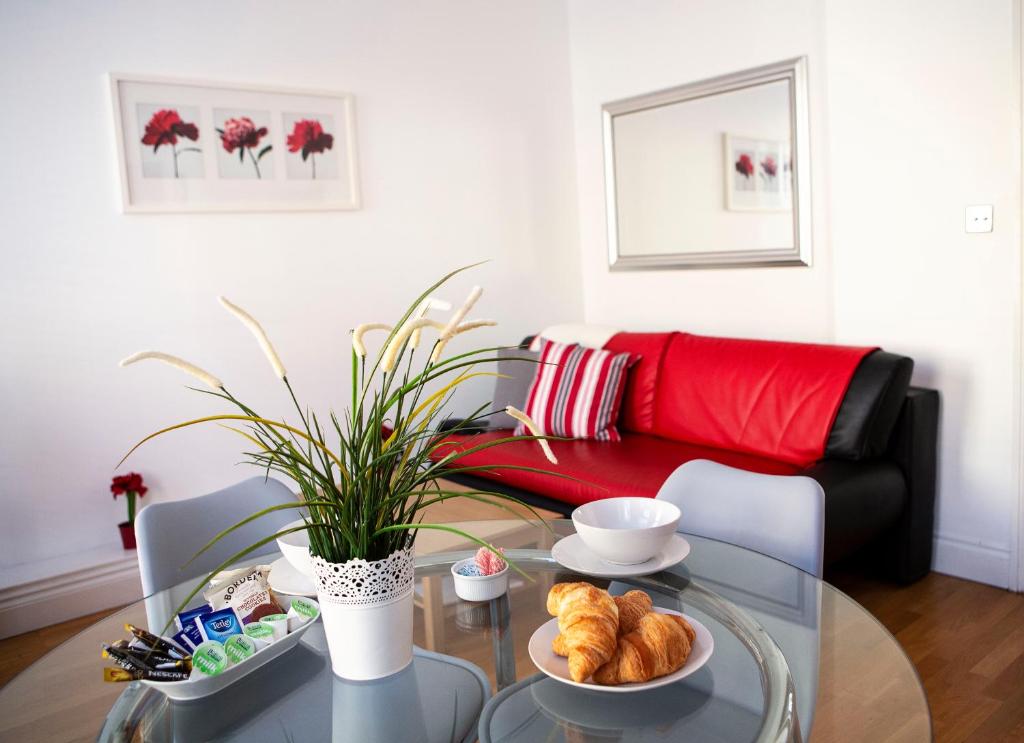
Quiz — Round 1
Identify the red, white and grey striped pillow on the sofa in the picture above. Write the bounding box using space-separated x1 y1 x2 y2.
515 340 635 441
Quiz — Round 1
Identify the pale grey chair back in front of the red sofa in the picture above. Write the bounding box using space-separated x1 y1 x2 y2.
656 460 825 577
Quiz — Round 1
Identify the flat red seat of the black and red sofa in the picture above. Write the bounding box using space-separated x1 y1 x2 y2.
435 430 800 506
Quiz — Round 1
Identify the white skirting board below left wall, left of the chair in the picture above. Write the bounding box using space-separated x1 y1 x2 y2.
0 553 142 638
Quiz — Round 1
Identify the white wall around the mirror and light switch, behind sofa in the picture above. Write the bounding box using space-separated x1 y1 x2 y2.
569 0 1021 585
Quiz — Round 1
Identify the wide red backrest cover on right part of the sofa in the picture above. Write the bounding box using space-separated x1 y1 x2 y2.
653 333 874 469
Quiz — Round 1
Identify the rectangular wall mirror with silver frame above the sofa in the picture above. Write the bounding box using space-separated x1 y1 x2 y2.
603 57 811 270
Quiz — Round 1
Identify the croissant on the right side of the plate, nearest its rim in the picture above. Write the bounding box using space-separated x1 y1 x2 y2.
594 612 696 686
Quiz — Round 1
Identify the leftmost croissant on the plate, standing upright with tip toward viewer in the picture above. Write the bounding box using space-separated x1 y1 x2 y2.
548 582 618 682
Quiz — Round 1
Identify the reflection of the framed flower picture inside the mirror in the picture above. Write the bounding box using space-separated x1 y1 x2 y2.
724 134 793 212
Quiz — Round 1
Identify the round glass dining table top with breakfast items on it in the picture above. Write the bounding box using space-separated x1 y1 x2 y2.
0 521 931 743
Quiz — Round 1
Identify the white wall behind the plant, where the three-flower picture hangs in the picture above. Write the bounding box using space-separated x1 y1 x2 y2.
0 0 581 567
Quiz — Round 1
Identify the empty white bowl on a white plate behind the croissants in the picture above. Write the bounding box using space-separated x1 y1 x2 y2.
572 498 681 565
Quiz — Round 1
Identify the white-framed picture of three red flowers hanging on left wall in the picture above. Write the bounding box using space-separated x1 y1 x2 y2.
111 75 359 213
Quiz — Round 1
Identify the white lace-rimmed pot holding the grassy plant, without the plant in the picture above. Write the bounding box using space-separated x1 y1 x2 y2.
311 549 413 681
